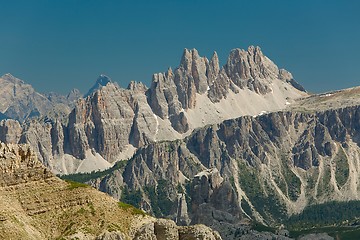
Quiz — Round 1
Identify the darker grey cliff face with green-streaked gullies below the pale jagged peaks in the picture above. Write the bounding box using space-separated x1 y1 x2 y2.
92 105 360 239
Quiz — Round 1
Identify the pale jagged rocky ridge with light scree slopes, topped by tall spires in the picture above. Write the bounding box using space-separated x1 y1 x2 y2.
0 46 308 174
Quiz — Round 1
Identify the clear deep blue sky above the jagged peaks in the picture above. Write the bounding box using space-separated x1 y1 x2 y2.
0 0 360 93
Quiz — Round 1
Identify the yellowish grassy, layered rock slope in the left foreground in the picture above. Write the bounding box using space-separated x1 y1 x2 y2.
0 142 221 240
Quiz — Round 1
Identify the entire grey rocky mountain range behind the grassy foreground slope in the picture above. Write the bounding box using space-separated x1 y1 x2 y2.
0 46 360 239
